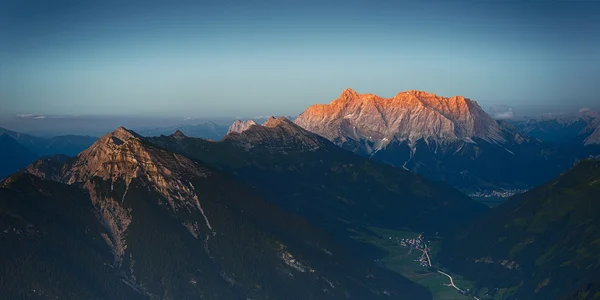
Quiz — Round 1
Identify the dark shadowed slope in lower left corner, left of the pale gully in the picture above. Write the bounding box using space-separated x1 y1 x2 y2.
0 174 150 299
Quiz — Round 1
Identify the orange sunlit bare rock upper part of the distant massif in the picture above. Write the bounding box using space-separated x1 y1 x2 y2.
295 89 505 152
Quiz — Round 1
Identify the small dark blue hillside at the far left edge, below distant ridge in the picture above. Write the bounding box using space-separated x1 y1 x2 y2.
0 132 36 179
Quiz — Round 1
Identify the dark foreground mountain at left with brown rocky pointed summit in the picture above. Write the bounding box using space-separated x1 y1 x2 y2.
0 128 431 299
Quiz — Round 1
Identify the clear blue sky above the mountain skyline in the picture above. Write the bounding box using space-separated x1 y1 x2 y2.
0 0 600 131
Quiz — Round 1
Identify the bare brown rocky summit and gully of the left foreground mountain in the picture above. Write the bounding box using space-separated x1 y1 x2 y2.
55 127 213 265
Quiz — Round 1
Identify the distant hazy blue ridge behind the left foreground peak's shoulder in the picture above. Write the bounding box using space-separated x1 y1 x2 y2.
0 128 97 156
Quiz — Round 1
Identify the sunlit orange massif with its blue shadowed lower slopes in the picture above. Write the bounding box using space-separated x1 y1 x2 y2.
295 89 574 192
